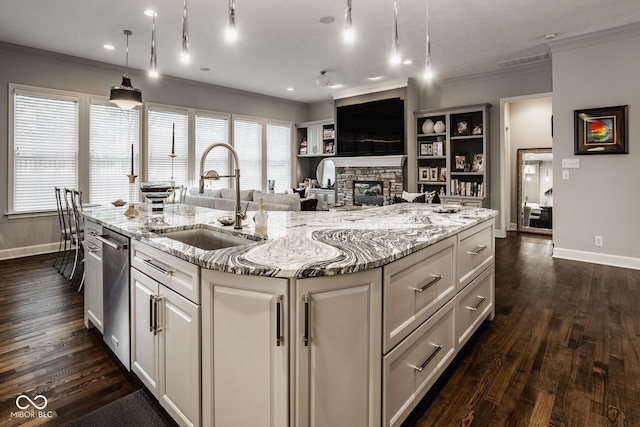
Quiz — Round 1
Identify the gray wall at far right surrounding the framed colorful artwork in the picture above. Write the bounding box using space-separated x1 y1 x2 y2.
552 26 640 268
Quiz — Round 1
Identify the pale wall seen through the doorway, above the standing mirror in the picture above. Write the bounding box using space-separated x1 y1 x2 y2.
508 98 553 224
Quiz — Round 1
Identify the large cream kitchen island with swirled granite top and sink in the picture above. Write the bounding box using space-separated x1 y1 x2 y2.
84 204 497 426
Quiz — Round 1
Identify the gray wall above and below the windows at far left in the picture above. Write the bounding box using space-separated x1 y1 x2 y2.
0 44 308 259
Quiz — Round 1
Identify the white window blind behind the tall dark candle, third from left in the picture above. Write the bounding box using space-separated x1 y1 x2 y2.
147 108 189 185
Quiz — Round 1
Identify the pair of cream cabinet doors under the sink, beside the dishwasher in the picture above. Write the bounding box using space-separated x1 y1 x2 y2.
131 269 200 426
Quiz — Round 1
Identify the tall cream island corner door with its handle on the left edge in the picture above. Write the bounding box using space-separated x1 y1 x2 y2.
293 268 382 427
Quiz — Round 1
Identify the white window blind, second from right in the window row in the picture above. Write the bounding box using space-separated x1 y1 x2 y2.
233 117 266 190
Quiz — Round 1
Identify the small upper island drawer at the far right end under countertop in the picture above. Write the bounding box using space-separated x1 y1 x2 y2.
457 220 494 292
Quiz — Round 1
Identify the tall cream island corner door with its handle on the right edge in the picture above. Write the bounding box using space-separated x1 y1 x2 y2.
202 270 291 427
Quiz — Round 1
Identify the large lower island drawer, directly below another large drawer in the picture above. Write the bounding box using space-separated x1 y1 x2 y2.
382 300 456 426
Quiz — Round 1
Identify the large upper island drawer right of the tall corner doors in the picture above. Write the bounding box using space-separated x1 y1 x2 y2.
383 237 456 353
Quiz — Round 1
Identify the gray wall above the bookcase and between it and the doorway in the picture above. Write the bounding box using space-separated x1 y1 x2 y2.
420 63 551 236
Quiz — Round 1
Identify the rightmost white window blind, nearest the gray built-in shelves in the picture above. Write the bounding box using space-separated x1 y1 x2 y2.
267 123 291 193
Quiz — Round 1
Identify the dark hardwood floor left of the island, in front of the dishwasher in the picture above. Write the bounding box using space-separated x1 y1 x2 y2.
0 255 141 426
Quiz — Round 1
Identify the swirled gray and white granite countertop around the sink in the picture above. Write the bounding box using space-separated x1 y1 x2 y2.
83 203 498 278
